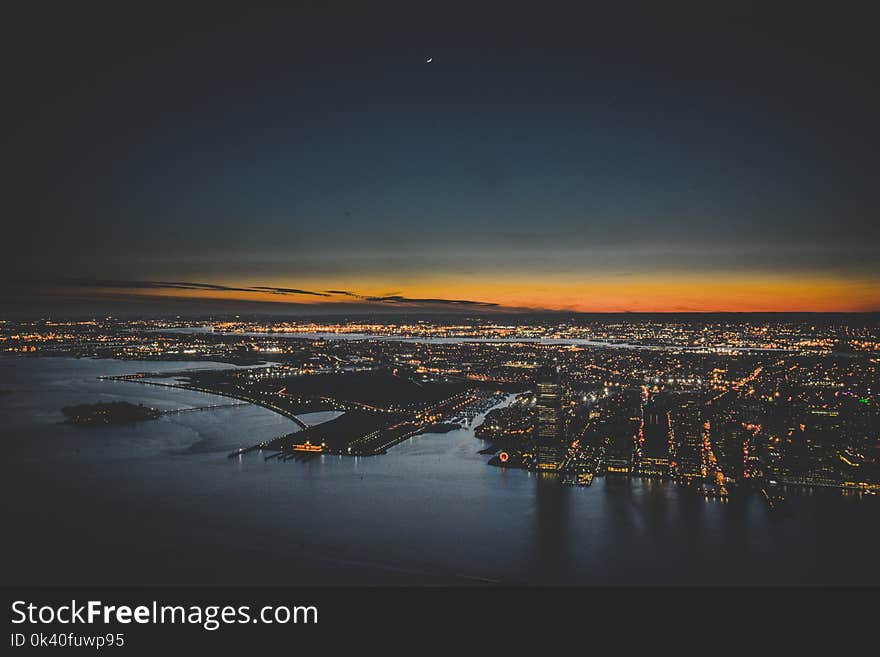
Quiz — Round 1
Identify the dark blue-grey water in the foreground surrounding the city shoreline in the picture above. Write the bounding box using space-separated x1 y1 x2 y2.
0 357 880 585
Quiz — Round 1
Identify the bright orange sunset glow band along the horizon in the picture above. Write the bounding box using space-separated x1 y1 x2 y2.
67 275 880 312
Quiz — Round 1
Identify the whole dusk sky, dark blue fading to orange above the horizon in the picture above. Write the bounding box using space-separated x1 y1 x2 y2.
0 3 880 312
